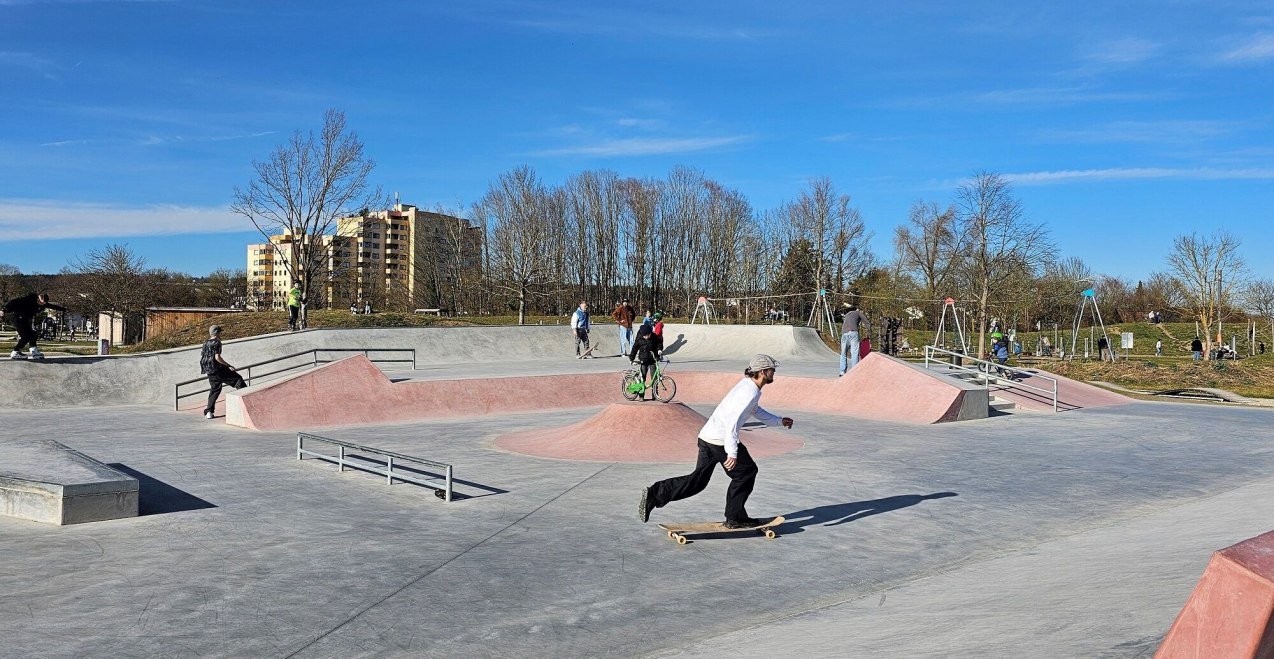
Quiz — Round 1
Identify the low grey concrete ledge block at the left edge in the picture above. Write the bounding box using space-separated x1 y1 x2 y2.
0 440 139 524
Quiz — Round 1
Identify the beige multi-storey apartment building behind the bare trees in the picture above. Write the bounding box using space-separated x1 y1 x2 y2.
247 204 482 310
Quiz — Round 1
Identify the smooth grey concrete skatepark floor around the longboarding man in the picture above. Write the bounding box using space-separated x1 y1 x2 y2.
0 361 1274 656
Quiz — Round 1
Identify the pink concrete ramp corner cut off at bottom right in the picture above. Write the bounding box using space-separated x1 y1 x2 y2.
1154 532 1274 659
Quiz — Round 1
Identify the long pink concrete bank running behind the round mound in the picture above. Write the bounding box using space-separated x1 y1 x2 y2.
225 353 987 431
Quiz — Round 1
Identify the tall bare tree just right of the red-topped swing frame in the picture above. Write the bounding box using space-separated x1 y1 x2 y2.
957 172 1055 357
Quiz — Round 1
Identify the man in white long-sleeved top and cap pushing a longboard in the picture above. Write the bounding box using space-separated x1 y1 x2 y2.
637 354 792 529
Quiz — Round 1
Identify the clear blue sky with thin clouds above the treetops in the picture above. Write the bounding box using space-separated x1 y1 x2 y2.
0 0 1274 279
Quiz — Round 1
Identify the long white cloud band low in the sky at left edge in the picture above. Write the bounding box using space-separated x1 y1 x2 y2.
0 199 243 241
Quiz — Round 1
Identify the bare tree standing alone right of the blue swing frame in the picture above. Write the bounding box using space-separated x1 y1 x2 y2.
1168 231 1243 357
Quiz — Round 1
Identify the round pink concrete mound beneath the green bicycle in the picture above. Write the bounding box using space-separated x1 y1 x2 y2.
496 402 805 463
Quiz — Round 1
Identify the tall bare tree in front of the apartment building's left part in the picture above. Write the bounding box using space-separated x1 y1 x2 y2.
231 110 383 324
